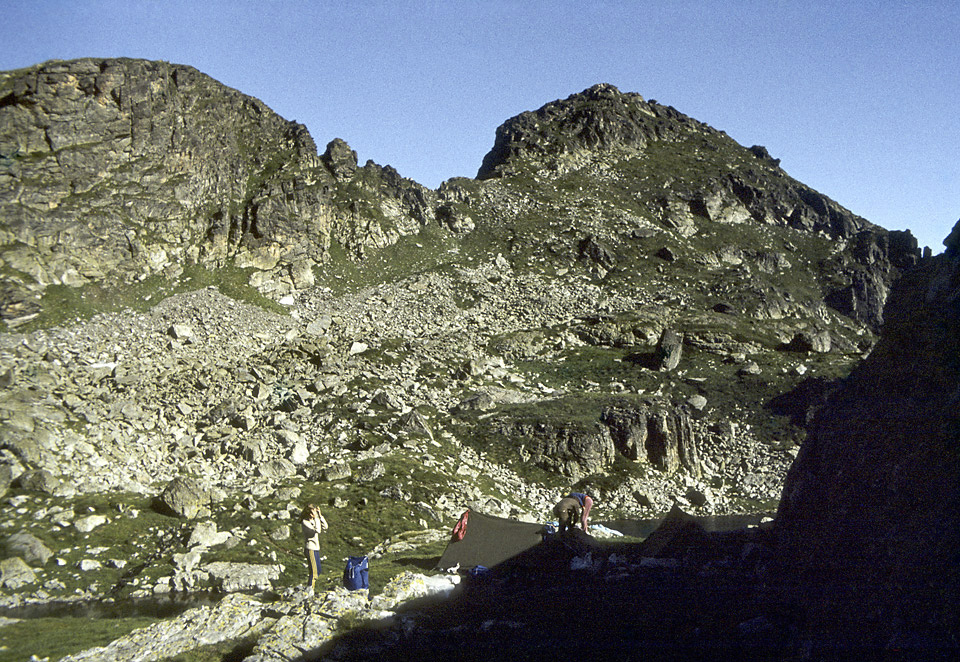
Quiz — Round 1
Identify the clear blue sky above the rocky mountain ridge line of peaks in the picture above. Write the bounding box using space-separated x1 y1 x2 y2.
0 0 960 253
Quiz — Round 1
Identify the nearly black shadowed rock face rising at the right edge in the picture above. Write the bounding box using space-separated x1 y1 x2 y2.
777 224 960 637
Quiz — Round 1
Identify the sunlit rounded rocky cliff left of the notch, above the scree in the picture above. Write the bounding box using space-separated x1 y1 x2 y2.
0 59 433 320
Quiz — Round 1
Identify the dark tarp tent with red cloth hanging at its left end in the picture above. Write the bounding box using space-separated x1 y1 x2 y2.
437 510 546 570
